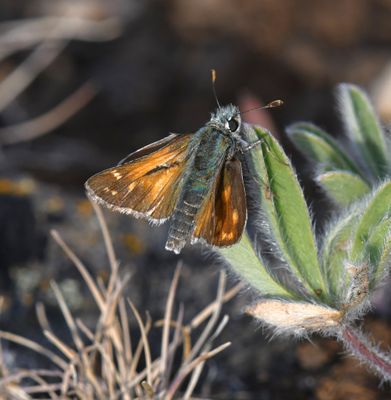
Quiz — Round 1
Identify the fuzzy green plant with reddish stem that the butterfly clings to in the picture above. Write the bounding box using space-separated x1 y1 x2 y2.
219 121 391 380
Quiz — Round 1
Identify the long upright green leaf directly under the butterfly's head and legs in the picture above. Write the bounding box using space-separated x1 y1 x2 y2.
246 127 326 298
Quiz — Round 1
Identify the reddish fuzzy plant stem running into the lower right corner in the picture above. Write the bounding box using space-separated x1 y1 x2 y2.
338 325 391 382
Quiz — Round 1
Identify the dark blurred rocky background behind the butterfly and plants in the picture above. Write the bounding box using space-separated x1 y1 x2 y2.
0 0 391 400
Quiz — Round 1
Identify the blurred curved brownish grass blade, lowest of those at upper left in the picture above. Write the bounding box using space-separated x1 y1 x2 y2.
0 81 97 144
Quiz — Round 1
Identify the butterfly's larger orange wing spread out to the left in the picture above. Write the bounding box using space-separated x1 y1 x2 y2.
85 134 192 223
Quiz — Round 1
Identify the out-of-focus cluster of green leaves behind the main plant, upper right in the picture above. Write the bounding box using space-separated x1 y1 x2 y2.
287 84 391 207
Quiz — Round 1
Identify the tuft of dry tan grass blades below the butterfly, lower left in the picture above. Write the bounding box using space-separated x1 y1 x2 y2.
0 205 237 400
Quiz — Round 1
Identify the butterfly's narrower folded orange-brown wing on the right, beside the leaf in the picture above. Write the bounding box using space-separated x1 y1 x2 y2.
193 160 247 247
